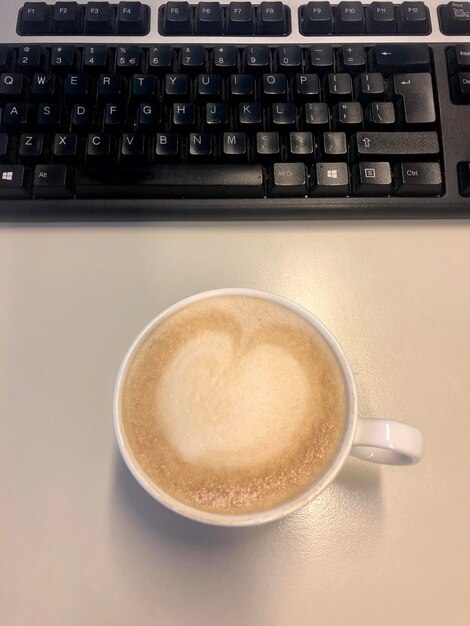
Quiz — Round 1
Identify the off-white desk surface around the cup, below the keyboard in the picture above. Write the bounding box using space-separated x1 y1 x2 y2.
0 221 470 626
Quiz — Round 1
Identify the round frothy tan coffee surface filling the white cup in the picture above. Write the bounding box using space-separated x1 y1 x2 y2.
122 295 346 513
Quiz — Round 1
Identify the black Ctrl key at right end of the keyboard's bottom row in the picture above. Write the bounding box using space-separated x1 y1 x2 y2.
394 162 443 196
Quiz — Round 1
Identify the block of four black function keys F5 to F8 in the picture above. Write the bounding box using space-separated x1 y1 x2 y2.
159 2 290 37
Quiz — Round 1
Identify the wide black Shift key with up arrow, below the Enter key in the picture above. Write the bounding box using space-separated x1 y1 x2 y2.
353 131 439 156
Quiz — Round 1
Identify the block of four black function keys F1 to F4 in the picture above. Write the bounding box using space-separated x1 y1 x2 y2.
17 2 150 35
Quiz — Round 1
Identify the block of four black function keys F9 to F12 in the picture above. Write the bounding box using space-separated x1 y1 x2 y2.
299 0 431 35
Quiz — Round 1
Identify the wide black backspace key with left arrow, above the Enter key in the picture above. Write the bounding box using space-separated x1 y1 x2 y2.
370 43 431 73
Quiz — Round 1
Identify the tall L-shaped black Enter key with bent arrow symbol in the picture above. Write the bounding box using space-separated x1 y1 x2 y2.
393 72 436 124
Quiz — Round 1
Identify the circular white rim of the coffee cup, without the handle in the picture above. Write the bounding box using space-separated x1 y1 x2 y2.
113 287 357 527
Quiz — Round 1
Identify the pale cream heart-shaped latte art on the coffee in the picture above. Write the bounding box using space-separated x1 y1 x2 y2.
155 331 311 469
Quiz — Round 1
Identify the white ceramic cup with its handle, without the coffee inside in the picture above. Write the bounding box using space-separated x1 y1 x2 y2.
114 288 423 526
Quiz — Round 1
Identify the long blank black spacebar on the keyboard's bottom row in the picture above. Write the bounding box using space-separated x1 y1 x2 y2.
75 164 265 198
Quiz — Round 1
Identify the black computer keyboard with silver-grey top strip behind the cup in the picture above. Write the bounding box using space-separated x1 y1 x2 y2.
0 0 470 220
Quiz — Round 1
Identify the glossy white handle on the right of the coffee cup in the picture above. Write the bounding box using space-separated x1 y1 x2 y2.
350 419 424 465
